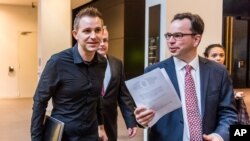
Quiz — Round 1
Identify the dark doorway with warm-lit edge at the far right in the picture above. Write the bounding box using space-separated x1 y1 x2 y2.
222 0 250 88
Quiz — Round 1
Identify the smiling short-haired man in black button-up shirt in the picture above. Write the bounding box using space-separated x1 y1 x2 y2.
31 7 107 141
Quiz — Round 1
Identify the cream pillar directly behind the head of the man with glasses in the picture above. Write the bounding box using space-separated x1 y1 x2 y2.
166 0 223 56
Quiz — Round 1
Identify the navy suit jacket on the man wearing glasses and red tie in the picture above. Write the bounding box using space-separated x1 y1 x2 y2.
145 57 237 141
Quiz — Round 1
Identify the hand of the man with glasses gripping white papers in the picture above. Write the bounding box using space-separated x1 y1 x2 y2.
134 107 155 127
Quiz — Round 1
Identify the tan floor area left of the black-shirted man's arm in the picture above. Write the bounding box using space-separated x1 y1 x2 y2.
0 99 32 141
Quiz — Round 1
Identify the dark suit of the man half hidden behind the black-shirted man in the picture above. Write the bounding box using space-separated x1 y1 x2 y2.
103 56 136 141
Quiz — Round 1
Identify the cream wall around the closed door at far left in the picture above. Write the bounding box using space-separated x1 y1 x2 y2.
0 5 37 98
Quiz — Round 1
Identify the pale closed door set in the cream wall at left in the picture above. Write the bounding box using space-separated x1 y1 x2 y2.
18 31 38 97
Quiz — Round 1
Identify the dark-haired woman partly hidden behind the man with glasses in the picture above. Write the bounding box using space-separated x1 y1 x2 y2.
204 44 250 125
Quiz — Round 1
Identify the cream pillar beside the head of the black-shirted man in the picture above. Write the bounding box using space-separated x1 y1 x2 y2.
38 0 72 73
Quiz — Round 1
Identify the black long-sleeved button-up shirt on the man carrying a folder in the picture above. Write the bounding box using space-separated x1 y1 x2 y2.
31 45 107 141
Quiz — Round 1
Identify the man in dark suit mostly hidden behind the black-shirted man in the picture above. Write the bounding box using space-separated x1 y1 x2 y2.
98 26 137 141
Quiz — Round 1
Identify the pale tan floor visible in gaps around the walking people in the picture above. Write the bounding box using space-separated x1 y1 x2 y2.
0 89 250 141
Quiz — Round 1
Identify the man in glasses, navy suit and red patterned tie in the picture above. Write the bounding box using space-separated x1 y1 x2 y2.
134 13 237 141
